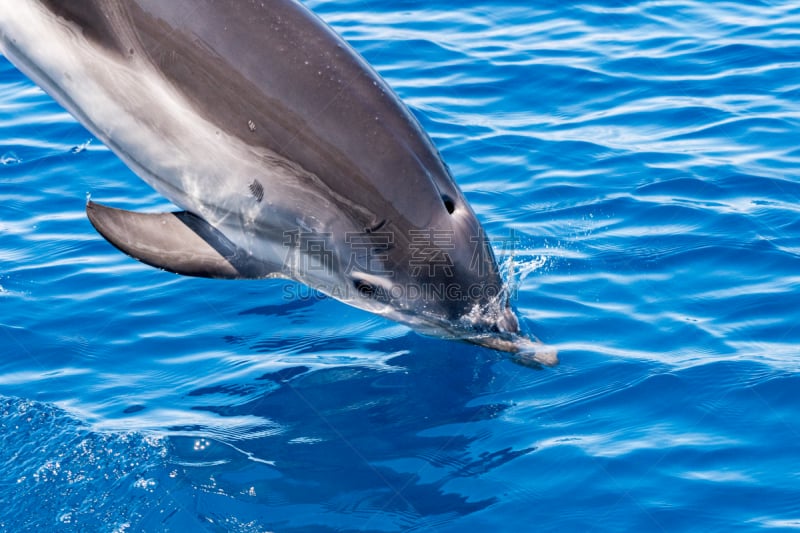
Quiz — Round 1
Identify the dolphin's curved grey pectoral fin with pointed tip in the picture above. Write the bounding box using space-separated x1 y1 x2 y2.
86 202 269 279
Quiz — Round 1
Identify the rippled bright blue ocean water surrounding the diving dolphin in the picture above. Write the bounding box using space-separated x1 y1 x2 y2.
0 0 800 532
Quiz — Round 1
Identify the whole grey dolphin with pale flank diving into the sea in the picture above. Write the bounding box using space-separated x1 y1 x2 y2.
0 0 558 366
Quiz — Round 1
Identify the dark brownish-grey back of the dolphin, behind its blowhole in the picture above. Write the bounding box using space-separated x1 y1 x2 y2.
45 0 450 227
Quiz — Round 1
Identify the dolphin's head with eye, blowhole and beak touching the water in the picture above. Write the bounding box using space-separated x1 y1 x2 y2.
300 177 558 366
